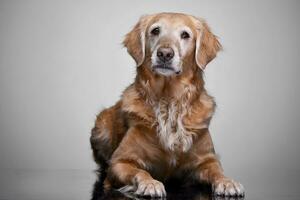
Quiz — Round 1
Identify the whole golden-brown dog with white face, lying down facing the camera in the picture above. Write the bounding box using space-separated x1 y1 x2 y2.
90 13 244 197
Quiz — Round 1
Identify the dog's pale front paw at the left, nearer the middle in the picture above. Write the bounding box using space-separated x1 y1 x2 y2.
135 179 167 197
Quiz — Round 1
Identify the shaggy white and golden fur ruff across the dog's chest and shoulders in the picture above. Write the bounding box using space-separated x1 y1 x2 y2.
122 87 214 152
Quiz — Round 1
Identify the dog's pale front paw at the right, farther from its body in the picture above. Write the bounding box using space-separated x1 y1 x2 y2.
212 178 245 197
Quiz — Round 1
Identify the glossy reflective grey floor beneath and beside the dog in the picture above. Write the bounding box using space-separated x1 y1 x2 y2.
0 170 300 200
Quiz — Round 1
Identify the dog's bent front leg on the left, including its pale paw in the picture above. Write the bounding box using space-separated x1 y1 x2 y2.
108 127 166 197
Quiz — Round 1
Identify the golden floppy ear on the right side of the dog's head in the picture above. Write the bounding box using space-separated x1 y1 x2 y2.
194 18 222 70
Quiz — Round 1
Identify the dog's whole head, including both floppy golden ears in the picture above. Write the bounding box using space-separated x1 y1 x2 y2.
123 13 221 76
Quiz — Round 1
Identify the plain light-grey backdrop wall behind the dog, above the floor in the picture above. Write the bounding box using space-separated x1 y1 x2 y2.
0 0 300 191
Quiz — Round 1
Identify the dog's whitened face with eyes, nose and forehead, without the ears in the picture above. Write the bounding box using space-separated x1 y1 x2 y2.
146 16 195 76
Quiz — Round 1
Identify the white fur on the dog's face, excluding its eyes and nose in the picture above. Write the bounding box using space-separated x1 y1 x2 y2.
148 20 194 76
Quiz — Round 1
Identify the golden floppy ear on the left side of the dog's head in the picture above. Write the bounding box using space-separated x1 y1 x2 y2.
123 15 151 66
